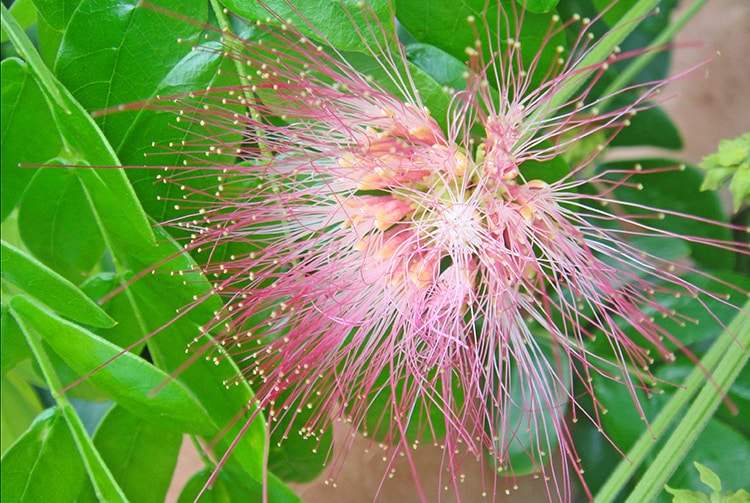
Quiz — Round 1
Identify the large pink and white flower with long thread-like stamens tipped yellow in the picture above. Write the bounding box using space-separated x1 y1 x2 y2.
128 2 746 500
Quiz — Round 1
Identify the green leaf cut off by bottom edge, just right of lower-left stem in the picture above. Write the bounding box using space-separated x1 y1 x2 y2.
81 406 182 503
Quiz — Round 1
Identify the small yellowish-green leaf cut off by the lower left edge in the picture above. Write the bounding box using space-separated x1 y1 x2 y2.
0 368 42 452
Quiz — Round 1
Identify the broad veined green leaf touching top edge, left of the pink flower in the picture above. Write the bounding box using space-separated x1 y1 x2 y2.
54 0 207 142
